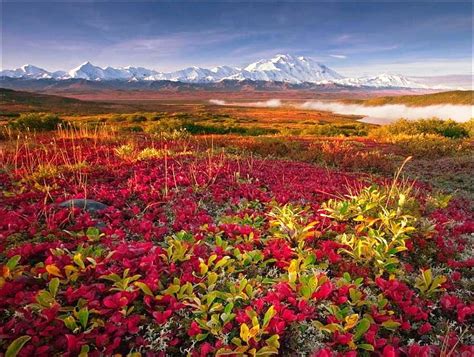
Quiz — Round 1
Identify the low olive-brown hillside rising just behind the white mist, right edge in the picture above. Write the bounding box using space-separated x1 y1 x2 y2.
345 90 474 107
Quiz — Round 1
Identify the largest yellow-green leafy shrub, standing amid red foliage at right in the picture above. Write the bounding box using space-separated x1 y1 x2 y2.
323 174 419 273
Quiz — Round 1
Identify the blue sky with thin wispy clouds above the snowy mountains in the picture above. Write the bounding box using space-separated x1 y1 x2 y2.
0 0 473 76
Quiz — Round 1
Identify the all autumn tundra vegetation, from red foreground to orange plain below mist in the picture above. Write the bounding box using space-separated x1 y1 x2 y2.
0 88 474 357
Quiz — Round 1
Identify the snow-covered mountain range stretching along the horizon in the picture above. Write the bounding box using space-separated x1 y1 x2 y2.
0 54 428 88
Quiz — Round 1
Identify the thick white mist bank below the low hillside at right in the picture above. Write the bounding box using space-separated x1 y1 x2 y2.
297 101 474 124
